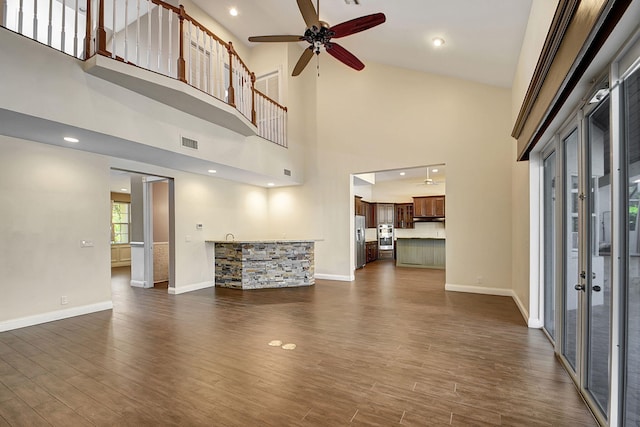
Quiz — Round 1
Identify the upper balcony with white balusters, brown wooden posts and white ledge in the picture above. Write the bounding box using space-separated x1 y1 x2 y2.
0 0 287 148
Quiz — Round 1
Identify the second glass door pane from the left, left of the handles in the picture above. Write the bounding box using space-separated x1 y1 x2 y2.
562 129 580 373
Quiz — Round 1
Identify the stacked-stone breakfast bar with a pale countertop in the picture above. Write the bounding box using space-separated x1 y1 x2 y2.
207 240 315 289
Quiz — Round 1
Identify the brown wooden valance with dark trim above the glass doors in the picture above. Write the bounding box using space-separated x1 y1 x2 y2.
512 0 631 160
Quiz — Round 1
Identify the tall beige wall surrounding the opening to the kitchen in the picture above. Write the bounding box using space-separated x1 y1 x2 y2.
271 56 512 289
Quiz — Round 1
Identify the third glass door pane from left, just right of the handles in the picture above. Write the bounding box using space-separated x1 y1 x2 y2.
583 97 611 414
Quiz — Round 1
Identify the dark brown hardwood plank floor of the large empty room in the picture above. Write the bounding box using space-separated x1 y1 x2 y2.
0 261 596 426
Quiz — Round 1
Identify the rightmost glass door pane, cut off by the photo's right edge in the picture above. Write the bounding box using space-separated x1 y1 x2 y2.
622 65 640 426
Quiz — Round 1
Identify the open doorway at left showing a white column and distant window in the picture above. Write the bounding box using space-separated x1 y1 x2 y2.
111 169 175 289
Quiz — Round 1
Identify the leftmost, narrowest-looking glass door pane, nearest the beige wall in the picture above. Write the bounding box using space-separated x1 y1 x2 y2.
543 151 556 340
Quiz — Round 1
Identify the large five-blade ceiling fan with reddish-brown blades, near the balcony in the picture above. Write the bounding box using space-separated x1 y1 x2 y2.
249 0 386 76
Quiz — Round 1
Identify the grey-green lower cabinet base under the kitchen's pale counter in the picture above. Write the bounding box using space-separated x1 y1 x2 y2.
396 238 446 269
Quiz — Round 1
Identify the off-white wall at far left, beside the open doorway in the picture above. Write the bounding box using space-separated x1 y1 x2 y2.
0 136 111 330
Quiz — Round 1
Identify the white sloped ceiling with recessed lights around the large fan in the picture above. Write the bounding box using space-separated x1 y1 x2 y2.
193 0 532 87
